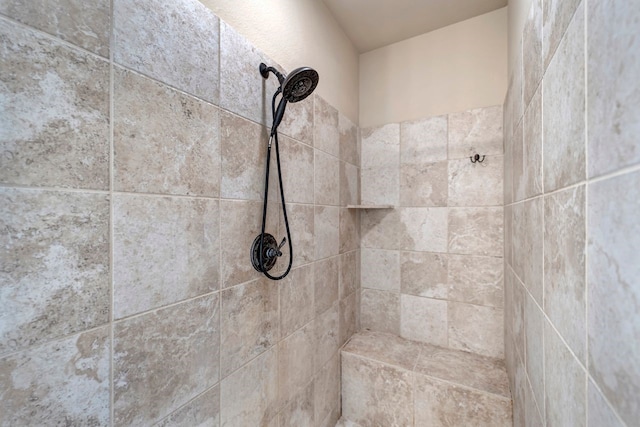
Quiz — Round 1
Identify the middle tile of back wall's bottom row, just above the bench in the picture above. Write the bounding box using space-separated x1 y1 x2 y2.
400 295 447 346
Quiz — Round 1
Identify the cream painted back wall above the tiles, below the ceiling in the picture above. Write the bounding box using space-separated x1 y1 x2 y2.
360 7 507 128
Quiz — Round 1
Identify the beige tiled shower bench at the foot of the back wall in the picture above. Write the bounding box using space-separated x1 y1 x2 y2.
337 331 513 427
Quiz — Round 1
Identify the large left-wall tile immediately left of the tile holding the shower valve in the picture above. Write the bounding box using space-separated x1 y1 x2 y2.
113 194 220 318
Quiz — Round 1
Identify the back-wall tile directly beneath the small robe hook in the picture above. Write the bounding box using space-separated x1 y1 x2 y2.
449 156 504 206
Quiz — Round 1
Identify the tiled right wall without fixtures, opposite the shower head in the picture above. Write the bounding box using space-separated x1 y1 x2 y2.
504 0 640 427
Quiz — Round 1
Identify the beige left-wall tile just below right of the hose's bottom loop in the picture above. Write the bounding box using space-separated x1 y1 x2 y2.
278 265 315 337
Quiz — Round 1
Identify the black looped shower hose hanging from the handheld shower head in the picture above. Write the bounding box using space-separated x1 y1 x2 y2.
260 88 293 280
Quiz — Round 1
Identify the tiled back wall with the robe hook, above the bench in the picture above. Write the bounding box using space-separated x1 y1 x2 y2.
361 106 504 357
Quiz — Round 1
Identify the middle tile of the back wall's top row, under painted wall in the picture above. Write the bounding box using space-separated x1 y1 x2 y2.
400 116 447 166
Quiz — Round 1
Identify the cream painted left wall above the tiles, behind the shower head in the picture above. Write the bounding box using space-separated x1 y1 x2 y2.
200 0 358 123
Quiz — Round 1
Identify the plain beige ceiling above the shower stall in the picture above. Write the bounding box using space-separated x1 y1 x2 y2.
322 0 507 53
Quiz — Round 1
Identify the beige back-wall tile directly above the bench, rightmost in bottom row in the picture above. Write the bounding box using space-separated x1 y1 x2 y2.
447 302 504 358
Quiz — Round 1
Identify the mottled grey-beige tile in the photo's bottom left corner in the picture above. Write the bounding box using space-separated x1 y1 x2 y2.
0 328 110 426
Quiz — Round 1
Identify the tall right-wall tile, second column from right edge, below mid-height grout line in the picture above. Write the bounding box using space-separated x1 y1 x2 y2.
544 186 587 363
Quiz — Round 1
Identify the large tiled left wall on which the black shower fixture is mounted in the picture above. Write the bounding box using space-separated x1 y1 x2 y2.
0 0 359 426
